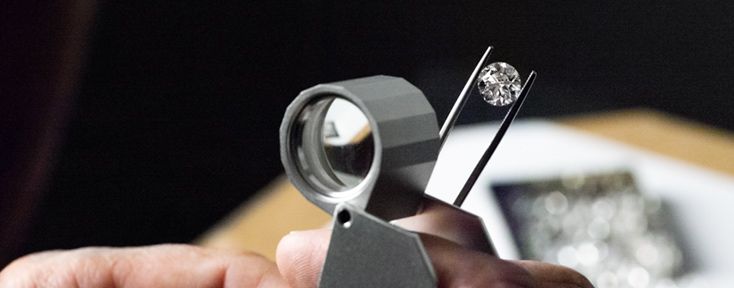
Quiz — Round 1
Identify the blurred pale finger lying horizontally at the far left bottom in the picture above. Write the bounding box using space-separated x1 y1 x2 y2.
0 244 287 287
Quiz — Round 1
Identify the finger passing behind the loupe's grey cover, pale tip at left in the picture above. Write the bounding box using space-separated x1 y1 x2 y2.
277 229 593 288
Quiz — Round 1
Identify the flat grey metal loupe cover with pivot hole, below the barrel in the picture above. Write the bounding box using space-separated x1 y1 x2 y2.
319 204 437 288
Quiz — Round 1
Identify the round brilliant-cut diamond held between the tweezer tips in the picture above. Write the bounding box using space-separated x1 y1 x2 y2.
477 62 522 106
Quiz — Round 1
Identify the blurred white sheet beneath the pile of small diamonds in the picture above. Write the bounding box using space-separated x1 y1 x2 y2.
427 121 734 287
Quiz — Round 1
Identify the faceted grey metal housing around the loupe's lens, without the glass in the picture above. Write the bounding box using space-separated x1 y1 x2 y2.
280 76 440 220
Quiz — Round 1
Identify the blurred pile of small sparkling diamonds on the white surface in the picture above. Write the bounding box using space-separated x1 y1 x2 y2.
500 173 697 288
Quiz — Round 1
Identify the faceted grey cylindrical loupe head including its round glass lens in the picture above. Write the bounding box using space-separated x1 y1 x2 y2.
280 76 439 220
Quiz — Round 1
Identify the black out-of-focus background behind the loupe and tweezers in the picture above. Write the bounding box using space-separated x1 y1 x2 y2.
7 1 734 260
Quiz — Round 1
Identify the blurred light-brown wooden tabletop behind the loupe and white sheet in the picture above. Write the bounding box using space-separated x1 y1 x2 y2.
195 109 734 259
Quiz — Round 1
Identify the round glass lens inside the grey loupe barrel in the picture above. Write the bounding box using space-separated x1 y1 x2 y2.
291 95 375 196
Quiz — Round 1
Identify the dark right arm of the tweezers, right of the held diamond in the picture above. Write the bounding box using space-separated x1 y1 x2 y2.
452 71 537 207
